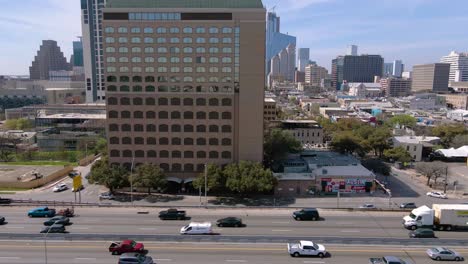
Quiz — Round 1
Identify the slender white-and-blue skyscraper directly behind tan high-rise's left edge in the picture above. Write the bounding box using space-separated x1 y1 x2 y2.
81 0 106 103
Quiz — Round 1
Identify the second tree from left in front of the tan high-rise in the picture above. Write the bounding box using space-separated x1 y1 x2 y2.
133 163 167 194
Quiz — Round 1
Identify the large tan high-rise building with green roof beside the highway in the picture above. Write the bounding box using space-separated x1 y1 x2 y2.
103 0 266 183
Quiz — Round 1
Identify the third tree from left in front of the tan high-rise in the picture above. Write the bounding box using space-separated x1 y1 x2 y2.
193 164 226 193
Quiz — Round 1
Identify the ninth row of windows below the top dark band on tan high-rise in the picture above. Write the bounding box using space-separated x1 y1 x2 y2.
109 111 232 120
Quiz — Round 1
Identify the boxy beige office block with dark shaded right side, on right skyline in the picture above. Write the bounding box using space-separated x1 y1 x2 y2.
411 63 450 93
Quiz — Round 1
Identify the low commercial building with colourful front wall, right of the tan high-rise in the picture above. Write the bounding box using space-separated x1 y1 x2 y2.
274 150 375 196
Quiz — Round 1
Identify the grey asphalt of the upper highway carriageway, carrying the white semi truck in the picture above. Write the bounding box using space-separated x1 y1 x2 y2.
0 207 468 245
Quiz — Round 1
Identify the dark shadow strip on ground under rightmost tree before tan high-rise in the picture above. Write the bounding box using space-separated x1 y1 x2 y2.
208 196 296 206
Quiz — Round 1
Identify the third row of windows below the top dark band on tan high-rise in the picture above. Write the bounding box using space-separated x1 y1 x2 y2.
106 47 232 54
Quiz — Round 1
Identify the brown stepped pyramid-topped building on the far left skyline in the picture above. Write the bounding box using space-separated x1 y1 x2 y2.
29 40 71 80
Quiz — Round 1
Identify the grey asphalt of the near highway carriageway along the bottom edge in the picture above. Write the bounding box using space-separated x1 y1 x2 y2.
0 241 468 264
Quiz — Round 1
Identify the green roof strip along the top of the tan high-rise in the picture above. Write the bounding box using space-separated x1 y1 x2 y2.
107 0 263 8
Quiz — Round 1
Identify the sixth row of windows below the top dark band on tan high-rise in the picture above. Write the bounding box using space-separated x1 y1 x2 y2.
107 75 232 83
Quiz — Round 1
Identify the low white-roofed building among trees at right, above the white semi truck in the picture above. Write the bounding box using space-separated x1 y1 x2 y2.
393 136 440 161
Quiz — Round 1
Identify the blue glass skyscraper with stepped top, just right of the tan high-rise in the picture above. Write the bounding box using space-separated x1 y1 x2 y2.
265 12 296 85
